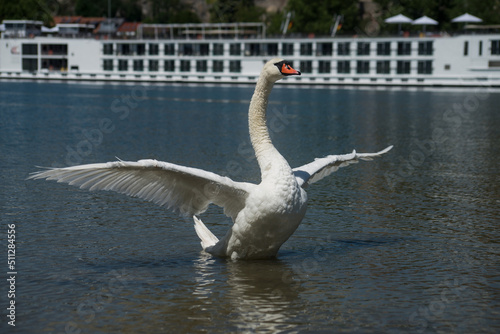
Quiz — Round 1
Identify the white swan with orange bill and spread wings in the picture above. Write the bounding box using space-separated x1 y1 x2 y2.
29 59 392 259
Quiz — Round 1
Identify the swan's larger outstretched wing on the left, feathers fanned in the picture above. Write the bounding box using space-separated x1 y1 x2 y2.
29 160 255 218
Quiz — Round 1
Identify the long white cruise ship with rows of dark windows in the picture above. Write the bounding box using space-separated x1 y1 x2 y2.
0 20 500 87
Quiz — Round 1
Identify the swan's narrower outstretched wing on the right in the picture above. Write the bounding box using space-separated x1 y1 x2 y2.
293 145 392 188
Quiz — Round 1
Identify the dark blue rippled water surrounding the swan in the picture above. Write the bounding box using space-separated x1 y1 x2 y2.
0 82 500 333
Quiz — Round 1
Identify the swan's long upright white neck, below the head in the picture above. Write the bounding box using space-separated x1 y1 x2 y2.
248 73 291 179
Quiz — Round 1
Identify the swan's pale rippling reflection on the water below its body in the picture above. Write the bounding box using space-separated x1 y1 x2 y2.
193 255 303 332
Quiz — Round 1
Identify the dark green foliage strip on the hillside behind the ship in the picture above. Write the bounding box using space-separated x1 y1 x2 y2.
0 0 500 35
